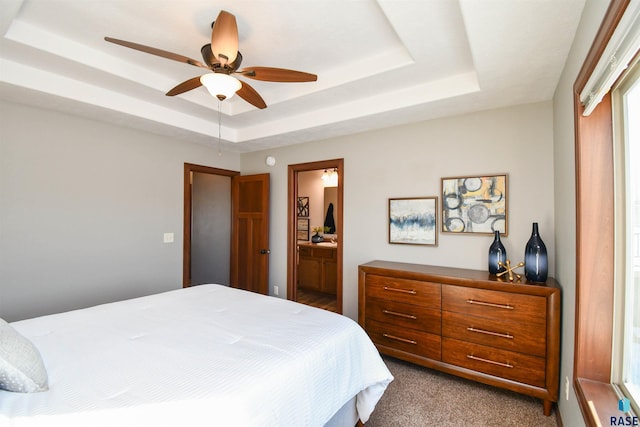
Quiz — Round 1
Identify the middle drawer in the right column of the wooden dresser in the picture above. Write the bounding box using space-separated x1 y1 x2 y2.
442 311 547 357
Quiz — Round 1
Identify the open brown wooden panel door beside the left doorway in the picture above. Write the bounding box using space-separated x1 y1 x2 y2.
231 173 269 295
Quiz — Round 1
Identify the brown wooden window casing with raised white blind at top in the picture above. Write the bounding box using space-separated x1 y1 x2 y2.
573 0 640 426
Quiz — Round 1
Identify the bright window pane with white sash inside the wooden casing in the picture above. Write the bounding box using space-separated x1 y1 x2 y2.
612 57 640 412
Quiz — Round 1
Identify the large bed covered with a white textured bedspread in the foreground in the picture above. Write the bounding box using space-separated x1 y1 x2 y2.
0 284 393 427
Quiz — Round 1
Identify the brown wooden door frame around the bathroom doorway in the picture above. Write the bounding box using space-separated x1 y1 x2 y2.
287 159 344 314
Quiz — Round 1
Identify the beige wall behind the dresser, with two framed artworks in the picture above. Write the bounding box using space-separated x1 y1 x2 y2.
242 102 555 319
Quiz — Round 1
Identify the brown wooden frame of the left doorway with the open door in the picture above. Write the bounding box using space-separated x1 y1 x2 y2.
182 163 240 288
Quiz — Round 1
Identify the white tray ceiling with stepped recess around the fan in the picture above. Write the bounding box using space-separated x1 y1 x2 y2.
0 0 585 152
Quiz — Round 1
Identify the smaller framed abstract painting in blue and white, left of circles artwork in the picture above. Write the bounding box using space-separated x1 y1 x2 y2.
389 197 438 246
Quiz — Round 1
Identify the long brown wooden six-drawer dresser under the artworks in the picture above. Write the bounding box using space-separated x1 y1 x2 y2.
358 261 560 415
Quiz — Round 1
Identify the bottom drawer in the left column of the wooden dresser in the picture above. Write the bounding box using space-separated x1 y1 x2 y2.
366 320 440 360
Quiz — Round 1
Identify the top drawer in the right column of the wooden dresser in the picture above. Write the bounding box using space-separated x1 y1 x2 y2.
442 285 547 325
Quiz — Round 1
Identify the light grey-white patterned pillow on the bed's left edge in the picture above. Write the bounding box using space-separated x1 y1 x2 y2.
0 319 49 393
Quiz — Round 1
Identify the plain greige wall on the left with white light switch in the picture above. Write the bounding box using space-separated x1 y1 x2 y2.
0 101 240 321
